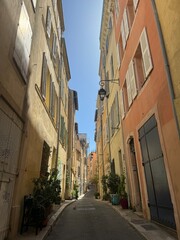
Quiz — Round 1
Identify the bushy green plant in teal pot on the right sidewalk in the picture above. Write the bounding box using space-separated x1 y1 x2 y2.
107 173 120 205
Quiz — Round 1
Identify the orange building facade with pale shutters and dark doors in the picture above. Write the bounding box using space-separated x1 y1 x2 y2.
113 0 180 235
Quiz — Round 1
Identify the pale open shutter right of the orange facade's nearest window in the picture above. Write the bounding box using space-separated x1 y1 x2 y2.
140 28 153 78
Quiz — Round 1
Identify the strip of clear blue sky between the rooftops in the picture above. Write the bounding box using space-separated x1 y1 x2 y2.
62 0 103 151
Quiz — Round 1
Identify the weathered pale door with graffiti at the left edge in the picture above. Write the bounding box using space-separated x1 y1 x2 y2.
0 98 23 240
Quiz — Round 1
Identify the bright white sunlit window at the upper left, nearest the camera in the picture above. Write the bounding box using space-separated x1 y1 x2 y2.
13 3 32 81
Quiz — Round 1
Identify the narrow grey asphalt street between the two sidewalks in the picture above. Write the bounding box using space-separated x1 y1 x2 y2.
47 190 144 240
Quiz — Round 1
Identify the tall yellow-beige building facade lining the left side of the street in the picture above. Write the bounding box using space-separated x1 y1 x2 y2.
0 0 70 239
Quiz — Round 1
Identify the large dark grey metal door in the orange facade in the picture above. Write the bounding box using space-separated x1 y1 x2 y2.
139 116 176 228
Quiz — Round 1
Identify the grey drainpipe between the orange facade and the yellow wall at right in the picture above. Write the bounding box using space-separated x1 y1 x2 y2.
151 0 180 134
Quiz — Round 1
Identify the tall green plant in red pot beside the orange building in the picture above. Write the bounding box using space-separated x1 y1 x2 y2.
118 174 128 209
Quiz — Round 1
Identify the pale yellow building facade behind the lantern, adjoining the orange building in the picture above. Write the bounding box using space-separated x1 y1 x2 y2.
95 1 126 199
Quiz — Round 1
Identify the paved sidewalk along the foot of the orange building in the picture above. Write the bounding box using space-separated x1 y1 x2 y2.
108 203 178 240
